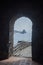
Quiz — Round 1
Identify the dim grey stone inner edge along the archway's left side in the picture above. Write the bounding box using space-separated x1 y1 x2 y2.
9 15 32 56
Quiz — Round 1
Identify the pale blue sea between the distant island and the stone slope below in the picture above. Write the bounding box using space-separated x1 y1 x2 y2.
13 32 32 46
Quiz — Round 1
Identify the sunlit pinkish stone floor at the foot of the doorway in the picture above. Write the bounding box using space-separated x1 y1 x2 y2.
0 57 41 65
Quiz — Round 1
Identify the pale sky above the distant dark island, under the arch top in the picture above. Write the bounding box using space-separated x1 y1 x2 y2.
14 17 32 32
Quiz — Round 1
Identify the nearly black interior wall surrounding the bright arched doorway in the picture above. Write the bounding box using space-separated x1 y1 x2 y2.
0 1 43 63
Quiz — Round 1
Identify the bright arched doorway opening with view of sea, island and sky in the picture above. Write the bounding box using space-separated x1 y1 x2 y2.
13 17 32 57
